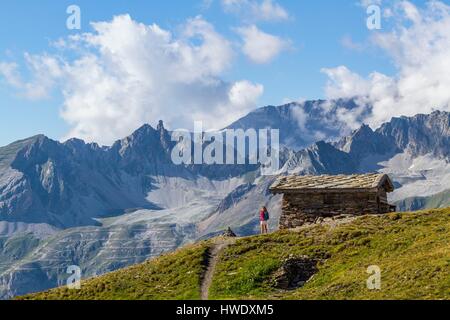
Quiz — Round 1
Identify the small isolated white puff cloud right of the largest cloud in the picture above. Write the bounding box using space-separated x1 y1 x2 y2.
237 25 290 64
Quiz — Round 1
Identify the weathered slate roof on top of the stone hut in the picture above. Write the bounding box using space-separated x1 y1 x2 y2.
270 173 394 193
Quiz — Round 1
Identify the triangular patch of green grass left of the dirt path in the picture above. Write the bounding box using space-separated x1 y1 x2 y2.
19 241 209 300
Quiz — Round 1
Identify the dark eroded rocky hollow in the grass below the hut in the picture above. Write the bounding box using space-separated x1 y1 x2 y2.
274 256 319 290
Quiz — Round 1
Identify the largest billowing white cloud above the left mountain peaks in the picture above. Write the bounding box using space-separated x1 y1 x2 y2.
0 15 263 144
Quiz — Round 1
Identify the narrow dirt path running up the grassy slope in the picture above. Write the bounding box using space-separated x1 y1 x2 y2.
200 238 236 300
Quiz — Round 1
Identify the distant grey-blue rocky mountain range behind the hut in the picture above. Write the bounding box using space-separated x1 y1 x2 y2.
0 100 450 298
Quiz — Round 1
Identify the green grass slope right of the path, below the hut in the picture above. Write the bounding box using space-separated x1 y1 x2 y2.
211 209 450 299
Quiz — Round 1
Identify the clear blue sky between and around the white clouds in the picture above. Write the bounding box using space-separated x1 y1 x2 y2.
0 0 445 145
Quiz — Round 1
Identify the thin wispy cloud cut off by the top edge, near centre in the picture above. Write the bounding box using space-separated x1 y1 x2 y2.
222 0 289 22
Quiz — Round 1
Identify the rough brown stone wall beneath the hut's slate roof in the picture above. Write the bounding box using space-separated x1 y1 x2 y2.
280 191 391 229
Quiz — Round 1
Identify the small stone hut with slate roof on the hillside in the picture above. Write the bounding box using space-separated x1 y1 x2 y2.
270 174 396 229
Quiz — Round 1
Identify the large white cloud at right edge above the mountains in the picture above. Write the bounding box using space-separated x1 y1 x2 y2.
323 1 450 126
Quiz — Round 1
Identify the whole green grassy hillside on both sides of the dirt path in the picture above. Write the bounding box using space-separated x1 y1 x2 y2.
21 208 450 299
